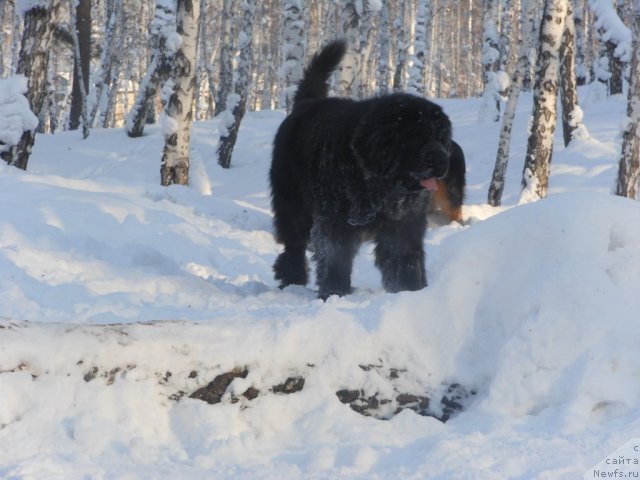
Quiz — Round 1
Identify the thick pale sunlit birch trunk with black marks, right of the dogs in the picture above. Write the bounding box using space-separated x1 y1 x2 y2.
520 0 567 203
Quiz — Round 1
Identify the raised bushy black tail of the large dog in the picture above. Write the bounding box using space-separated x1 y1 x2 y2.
293 40 347 105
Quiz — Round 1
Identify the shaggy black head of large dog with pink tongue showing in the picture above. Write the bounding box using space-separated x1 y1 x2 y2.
351 94 451 192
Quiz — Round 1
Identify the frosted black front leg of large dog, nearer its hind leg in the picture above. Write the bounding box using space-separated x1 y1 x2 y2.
311 219 359 300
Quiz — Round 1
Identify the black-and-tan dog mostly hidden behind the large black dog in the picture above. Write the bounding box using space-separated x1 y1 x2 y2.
431 140 467 223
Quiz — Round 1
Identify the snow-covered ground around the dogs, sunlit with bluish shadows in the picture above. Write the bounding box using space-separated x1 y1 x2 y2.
0 89 640 480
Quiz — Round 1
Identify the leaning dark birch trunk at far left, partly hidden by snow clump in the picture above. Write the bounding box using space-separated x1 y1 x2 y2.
3 0 53 170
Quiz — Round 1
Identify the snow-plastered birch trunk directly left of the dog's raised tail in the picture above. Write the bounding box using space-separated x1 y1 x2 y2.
281 0 305 113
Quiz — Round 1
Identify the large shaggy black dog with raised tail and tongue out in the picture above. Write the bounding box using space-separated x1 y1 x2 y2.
270 41 451 299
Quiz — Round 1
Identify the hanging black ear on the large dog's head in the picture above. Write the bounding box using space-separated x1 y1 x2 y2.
351 108 401 177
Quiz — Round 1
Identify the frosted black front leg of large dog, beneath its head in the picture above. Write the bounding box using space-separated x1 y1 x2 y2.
375 215 427 292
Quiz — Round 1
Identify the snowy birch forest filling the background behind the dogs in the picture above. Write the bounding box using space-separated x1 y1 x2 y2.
0 0 640 199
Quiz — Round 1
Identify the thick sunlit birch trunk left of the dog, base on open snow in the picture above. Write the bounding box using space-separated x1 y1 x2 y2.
160 0 200 185
